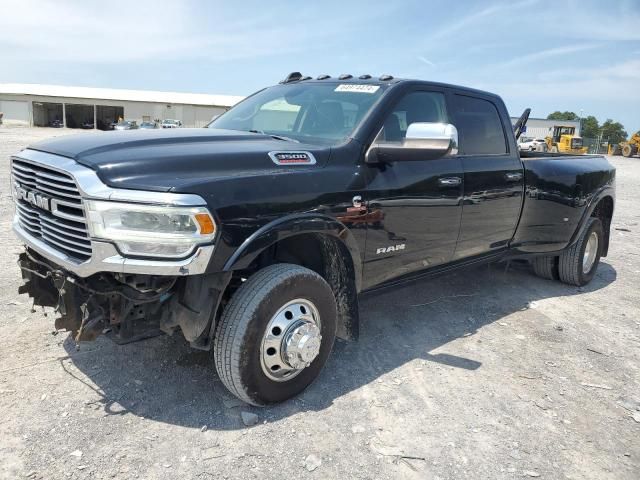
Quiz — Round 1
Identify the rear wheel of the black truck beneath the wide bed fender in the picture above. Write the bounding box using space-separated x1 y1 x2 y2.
558 217 604 287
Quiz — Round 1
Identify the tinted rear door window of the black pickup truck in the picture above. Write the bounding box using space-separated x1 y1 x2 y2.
455 95 507 155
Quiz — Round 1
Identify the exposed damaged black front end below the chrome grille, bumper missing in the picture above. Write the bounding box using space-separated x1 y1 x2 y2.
18 249 229 350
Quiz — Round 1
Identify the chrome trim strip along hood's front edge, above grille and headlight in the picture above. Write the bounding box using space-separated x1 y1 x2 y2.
12 149 206 207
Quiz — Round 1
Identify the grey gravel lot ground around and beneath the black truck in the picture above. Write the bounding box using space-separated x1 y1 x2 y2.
0 128 640 480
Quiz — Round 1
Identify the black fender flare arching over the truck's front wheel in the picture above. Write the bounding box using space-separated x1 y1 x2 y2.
223 214 362 292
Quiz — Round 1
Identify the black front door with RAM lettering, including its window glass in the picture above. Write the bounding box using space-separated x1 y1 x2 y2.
363 90 464 288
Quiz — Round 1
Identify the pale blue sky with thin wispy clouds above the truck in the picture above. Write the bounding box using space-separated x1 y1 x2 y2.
0 0 640 133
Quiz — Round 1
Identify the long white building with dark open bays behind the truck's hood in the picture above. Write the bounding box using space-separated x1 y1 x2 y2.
0 83 243 130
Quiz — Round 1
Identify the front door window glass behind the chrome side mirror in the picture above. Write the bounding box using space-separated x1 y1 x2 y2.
378 92 448 143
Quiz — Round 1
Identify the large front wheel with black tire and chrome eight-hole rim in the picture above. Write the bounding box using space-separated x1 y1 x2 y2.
214 264 337 406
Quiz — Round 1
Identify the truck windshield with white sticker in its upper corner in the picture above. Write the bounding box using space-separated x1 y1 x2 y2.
209 83 385 145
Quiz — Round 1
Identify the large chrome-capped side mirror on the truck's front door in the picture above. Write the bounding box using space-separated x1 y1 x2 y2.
365 122 458 163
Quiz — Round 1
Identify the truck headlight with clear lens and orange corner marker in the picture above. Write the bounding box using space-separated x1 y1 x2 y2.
86 200 216 258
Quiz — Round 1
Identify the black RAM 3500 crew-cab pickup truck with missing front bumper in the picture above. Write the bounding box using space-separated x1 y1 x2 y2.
12 73 615 405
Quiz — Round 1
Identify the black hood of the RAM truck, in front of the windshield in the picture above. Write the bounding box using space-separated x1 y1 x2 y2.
29 128 331 192
